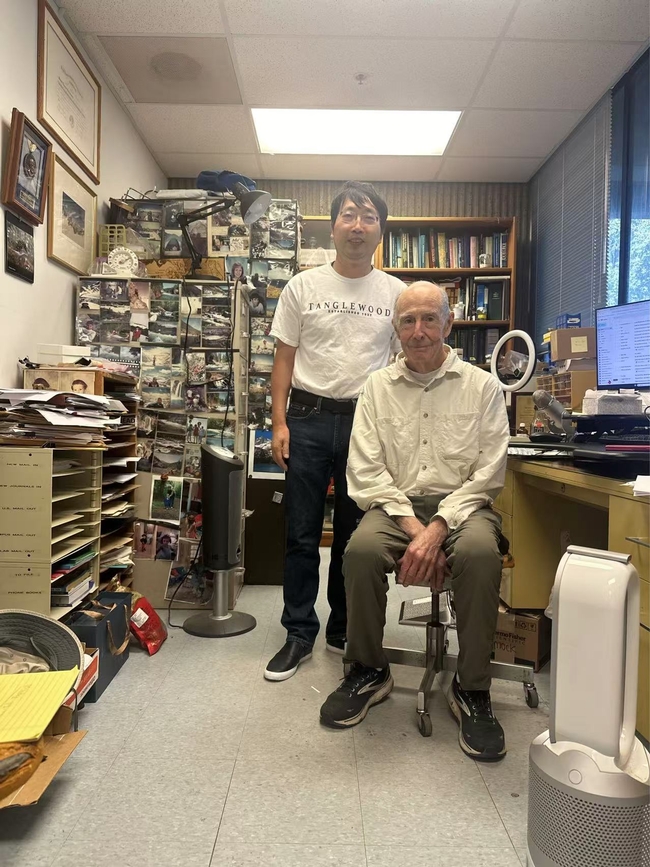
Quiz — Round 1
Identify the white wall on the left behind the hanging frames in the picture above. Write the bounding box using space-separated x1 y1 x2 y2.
0 0 166 387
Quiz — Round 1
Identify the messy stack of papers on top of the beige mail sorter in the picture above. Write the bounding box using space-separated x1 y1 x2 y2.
0 388 126 448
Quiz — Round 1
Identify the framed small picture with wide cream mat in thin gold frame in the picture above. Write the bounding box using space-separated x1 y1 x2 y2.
47 156 97 275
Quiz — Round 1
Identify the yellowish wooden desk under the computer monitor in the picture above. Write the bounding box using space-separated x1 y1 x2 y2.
494 458 650 740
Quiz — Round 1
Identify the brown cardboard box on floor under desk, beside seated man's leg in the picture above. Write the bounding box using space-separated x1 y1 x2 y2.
492 606 551 671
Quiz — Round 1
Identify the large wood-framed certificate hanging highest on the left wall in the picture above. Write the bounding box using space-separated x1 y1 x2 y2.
38 0 102 184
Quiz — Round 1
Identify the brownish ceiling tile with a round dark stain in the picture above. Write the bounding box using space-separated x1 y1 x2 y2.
99 36 241 105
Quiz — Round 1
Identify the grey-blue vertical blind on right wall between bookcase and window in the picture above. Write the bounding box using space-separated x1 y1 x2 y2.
530 93 611 343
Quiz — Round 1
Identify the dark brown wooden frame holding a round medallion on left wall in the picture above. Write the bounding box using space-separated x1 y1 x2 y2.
2 108 52 225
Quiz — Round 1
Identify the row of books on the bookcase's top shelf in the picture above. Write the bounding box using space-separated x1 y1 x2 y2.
383 229 508 268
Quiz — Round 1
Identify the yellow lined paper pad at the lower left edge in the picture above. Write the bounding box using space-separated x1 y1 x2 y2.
0 668 79 743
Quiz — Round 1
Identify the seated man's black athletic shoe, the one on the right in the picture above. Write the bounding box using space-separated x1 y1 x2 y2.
447 675 506 762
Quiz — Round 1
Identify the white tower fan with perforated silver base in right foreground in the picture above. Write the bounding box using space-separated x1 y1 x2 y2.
527 545 650 867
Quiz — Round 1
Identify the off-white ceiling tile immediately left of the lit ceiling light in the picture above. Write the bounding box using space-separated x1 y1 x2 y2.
128 104 257 154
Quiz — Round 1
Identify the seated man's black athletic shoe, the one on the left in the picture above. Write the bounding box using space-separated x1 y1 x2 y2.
320 662 393 729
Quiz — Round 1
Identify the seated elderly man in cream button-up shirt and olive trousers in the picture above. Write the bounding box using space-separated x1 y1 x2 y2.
321 282 509 761
